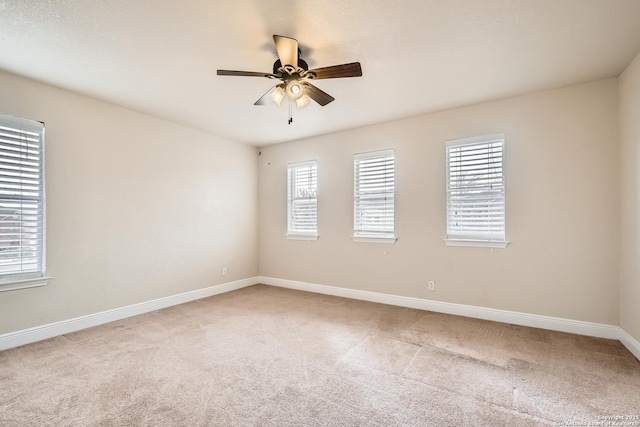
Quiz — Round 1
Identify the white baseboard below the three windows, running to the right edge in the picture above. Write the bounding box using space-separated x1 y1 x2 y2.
259 277 640 352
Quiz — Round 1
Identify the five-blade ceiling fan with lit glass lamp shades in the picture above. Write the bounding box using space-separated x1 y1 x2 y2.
218 35 362 112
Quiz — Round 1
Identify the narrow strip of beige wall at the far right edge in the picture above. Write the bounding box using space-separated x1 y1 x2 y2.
620 51 640 341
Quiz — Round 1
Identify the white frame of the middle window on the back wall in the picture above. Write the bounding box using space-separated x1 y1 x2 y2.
351 148 398 243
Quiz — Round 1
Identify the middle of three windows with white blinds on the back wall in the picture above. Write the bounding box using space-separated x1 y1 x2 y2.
353 150 396 243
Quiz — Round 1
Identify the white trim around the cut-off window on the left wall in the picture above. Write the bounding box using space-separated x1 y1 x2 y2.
0 114 52 292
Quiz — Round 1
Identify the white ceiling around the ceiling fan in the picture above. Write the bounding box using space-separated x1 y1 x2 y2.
0 0 640 146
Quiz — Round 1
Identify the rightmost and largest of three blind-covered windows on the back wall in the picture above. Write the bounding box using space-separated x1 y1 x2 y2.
445 134 508 248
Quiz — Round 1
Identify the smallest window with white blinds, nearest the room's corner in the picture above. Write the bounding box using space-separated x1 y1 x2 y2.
287 160 318 240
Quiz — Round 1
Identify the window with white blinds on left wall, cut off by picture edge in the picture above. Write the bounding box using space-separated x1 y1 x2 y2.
0 114 48 290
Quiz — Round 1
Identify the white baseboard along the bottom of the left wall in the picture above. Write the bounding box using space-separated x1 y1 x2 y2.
0 277 258 350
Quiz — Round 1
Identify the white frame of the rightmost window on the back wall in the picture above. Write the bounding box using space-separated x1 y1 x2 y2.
444 133 509 248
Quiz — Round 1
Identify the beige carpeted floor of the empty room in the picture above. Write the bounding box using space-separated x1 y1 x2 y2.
0 285 640 426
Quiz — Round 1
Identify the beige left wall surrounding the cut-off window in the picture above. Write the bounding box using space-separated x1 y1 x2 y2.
0 73 258 334
